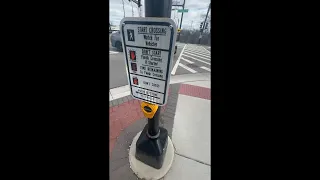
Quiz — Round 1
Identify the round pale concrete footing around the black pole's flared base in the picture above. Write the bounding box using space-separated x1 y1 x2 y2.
129 131 174 180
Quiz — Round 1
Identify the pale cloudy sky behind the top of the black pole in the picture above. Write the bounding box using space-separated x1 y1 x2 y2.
109 0 211 29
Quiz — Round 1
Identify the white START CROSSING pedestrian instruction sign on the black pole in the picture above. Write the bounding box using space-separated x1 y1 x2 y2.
120 17 177 106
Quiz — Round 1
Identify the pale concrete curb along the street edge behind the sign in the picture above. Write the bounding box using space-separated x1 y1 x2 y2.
109 73 211 101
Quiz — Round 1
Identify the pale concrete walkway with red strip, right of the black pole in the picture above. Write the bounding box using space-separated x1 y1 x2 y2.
164 81 211 180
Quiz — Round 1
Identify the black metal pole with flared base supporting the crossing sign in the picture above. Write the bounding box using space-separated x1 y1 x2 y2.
135 0 172 169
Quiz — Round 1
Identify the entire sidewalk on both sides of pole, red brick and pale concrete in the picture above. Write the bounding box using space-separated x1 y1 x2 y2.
109 76 211 180
